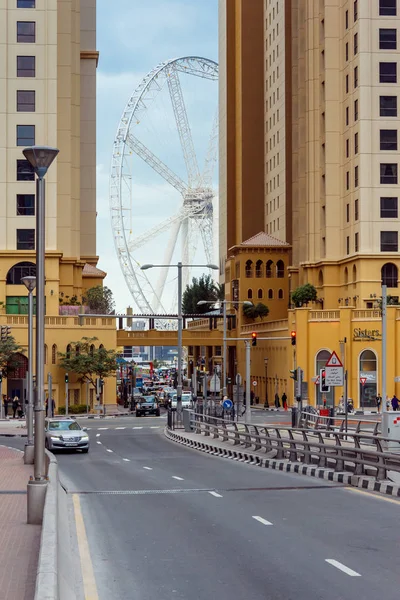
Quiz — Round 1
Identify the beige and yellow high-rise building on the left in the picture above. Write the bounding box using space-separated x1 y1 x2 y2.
0 0 116 405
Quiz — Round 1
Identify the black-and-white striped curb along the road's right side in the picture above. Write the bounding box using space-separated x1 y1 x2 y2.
164 427 400 497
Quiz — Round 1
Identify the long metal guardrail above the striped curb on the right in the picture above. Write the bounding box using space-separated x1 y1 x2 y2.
182 411 400 480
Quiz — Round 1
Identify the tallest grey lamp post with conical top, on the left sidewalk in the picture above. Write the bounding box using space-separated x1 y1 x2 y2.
23 146 59 524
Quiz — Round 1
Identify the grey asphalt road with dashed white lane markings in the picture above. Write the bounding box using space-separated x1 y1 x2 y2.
0 417 400 600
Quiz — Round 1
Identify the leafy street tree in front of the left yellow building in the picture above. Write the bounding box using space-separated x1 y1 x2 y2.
58 337 118 387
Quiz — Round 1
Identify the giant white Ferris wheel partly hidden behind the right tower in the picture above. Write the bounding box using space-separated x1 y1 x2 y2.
110 56 218 314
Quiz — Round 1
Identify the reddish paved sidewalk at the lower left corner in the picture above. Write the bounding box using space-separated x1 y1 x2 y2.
0 446 41 600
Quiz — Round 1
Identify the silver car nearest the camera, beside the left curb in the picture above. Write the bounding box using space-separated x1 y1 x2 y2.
45 417 90 454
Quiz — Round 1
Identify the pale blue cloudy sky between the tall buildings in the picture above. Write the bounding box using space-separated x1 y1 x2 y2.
97 0 218 312
